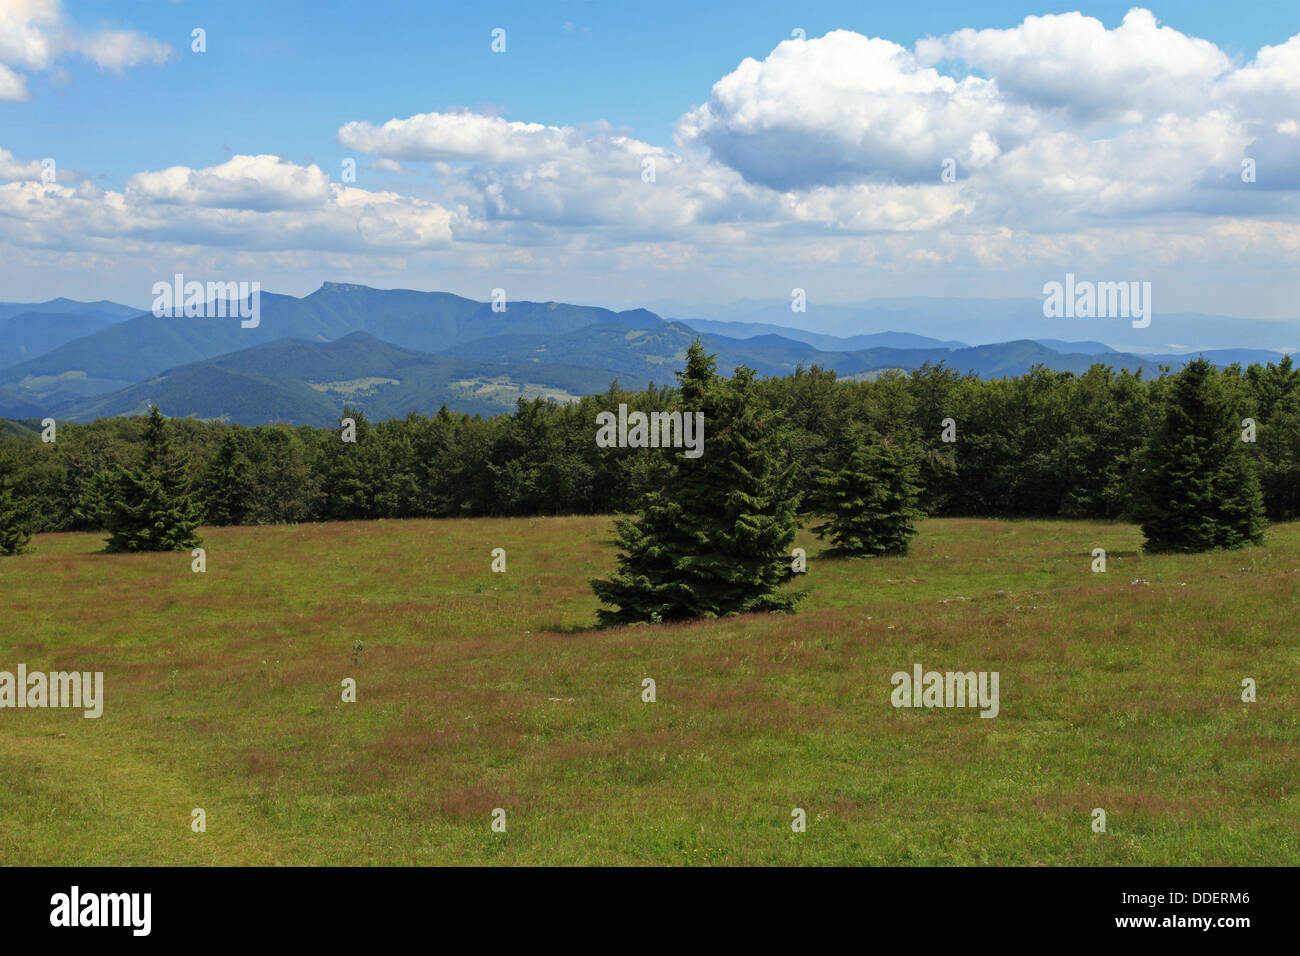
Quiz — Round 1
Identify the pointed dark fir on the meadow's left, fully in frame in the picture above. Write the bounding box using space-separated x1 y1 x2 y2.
107 406 202 551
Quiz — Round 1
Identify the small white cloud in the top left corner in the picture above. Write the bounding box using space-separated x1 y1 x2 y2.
0 0 172 100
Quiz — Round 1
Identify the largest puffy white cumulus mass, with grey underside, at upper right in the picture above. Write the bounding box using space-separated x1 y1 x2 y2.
677 9 1300 229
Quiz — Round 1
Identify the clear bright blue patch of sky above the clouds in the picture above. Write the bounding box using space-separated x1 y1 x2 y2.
0 0 1300 186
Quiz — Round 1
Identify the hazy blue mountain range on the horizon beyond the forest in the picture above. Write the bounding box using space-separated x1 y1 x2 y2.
0 282 1300 425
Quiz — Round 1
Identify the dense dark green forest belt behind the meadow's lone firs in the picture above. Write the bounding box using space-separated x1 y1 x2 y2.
0 359 1300 532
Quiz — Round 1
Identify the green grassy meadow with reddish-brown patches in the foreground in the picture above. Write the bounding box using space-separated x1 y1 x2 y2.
0 518 1300 865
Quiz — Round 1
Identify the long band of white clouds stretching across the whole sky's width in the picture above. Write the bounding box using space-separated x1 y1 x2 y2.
0 10 1300 291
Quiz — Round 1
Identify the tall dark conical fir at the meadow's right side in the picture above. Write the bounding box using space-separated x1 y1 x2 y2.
1134 359 1265 551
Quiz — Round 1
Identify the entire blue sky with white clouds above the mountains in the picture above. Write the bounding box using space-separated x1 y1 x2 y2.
0 0 1300 324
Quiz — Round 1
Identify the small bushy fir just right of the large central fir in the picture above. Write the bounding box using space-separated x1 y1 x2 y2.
814 423 922 558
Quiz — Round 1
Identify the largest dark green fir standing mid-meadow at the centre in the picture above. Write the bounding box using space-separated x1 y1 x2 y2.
592 341 801 626
